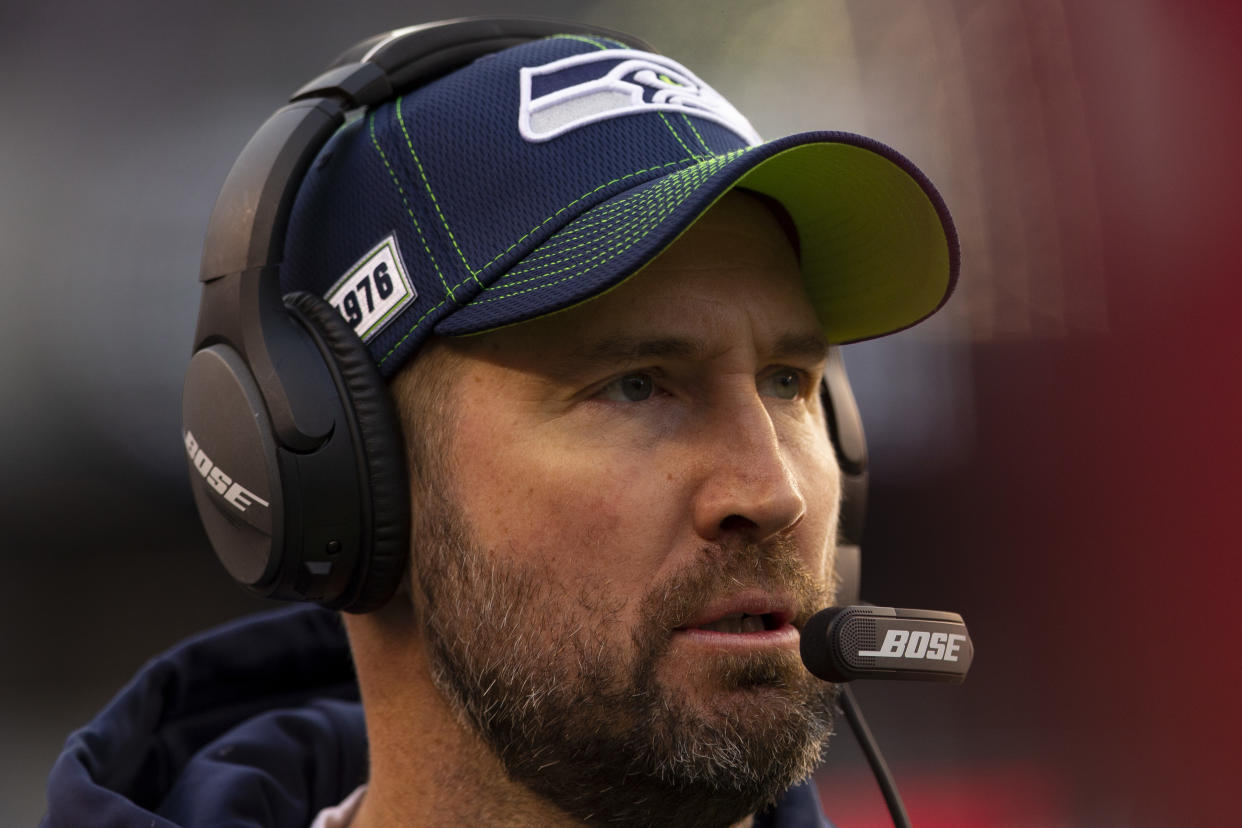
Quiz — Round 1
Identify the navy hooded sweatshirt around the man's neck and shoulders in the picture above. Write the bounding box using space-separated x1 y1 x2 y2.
41 606 828 828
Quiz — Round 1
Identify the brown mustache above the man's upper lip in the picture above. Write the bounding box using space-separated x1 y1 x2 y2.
641 538 833 634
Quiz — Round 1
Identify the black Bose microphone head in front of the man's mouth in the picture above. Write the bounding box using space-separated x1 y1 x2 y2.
800 606 975 684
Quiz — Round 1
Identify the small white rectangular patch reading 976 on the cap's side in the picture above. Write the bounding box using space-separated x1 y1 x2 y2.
324 236 419 343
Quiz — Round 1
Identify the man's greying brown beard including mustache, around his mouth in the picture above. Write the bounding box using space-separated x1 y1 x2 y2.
414 481 836 828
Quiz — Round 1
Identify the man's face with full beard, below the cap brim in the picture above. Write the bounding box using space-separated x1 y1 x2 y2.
410 192 840 824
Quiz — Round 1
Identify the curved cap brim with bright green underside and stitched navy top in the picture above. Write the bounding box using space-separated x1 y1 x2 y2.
436 133 959 344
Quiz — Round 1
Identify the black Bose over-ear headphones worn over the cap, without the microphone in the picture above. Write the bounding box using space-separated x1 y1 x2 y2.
181 19 867 612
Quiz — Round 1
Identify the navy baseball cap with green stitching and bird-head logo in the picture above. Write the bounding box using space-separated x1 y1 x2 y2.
281 35 958 377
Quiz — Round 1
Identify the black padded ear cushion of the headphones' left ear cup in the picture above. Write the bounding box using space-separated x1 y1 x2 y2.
284 292 410 612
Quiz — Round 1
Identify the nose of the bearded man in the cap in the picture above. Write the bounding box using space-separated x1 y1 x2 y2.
693 397 806 542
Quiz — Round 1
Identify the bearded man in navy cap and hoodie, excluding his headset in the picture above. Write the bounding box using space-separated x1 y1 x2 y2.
38 21 956 828
